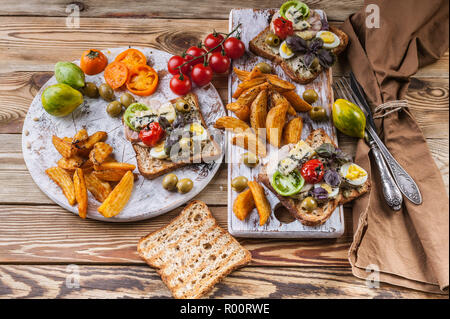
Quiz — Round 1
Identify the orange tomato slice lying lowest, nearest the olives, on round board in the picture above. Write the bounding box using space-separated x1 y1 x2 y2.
127 64 158 96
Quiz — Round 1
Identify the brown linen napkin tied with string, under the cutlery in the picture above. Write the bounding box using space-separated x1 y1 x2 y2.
343 0 449 293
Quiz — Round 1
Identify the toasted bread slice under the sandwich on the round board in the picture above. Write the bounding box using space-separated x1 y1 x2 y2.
133 93 221 179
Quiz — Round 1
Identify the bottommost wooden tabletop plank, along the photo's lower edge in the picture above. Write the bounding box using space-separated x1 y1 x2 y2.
0 265 442 299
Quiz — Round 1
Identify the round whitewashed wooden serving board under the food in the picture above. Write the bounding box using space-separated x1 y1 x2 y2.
22 47 225 222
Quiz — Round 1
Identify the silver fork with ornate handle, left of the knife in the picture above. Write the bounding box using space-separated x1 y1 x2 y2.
333 79 403 211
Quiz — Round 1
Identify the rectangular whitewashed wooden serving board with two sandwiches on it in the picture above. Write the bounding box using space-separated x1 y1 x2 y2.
226 9 344 238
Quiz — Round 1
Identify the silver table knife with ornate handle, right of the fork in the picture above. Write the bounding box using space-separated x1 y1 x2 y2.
350 72 422 205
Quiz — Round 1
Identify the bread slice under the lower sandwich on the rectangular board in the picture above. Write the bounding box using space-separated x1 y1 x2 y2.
258 129 370 226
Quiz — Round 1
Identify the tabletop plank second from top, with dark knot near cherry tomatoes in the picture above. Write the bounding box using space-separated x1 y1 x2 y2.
0 17 448 77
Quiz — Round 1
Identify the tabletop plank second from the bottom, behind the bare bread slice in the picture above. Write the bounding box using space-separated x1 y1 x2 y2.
0 205 352 267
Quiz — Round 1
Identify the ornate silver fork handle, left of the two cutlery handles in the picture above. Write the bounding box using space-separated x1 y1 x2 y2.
369 139 403 210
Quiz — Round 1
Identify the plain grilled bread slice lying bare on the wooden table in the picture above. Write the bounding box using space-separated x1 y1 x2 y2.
137 201 251 299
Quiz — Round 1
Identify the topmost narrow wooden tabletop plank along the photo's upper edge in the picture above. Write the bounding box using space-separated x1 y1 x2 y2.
0 0 363 23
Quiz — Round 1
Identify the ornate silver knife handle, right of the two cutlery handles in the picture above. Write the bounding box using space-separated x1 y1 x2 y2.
367 125 422 205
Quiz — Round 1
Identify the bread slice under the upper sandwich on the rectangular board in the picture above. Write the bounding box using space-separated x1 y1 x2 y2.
249 26 348 84
